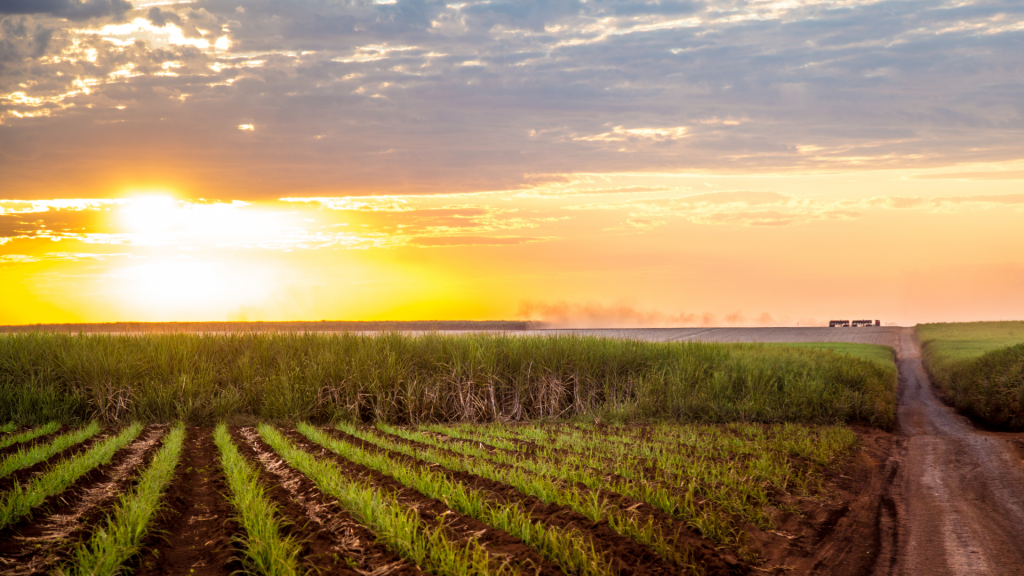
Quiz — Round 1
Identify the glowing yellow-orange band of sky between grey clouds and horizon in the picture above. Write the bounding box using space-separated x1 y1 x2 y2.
0 167 1024 325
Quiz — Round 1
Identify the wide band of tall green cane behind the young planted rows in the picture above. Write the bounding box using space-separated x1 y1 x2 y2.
0 333 895 426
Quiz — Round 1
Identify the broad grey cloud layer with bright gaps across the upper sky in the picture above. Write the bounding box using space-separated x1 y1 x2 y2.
0 0 1024 193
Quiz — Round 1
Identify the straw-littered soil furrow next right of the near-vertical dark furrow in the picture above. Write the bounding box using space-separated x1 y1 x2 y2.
231 427 424 576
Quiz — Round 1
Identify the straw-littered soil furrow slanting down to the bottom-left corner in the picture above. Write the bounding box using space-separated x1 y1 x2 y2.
0 425 167 576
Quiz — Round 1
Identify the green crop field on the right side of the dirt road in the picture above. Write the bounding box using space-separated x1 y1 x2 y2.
918 322 1024 430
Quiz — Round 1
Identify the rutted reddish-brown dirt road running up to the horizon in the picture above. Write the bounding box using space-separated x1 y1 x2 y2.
880 328 1024 576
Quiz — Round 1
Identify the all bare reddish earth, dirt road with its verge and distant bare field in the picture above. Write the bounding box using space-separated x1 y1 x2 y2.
538 327 1024 576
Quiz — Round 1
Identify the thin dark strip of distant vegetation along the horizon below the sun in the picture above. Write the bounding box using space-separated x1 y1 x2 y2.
0 320 545 334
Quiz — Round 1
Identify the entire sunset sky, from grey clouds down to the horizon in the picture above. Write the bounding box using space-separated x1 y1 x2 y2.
0 0 1024 327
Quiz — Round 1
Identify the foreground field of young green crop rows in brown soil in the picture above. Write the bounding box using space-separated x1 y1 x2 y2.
0 423 852 576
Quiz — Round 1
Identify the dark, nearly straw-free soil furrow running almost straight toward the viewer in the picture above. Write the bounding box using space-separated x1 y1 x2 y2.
134 427 243 576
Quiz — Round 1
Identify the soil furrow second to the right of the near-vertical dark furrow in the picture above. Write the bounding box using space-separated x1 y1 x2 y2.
282 430 562 576
